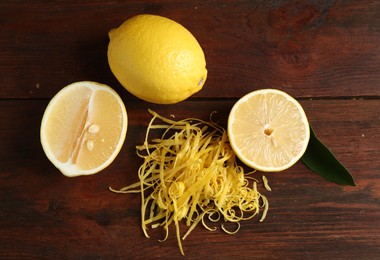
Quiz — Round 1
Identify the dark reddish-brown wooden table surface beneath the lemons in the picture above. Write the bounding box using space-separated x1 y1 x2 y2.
0 0 380 259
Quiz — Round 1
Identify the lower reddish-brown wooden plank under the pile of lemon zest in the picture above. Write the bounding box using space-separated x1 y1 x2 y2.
0 99 380 259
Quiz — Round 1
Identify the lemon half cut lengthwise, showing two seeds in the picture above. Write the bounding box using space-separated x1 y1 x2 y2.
40 81 128 177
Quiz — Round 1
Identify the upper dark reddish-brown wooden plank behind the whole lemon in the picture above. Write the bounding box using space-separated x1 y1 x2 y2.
0 0 380 99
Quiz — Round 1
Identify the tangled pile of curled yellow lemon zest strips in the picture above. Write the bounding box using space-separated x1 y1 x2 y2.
110 110 268 255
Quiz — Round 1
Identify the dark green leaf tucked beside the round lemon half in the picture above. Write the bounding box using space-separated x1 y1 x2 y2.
301 127 356 186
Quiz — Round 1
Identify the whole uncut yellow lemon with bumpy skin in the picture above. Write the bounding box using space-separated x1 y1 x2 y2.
108 14 207 104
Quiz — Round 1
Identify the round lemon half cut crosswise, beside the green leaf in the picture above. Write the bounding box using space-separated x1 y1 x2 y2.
228 89 310 172
